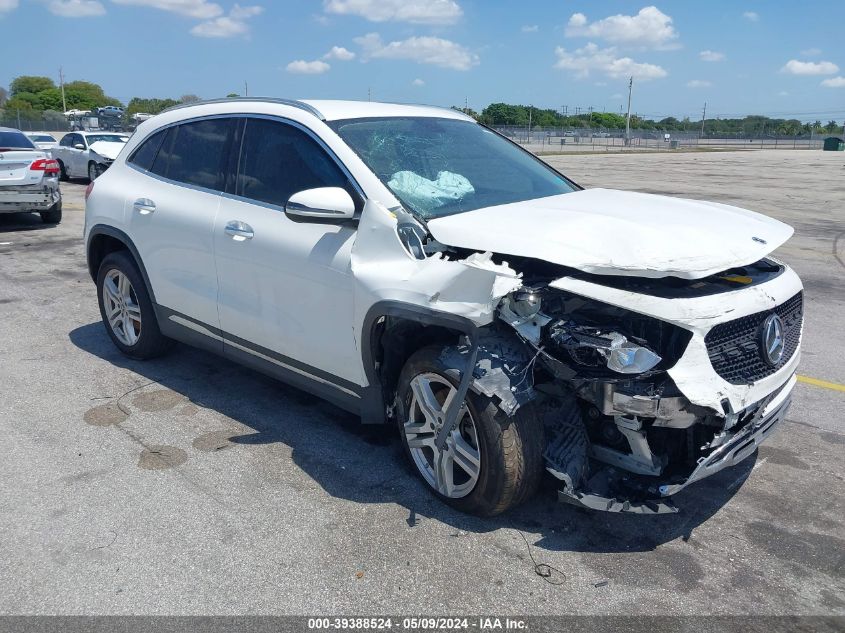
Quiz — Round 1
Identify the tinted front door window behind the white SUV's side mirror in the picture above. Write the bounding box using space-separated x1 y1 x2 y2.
235 118 348 207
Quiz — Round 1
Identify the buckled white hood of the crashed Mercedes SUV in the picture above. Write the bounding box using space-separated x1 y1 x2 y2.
428 189 793 279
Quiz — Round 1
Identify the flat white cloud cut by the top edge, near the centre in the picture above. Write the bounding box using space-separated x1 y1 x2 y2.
323 0 464 24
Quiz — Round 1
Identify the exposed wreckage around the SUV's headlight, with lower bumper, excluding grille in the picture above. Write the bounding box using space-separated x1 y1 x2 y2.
488 272 800 514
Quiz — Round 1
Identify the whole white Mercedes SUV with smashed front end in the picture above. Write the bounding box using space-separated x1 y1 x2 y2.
85 98 803 515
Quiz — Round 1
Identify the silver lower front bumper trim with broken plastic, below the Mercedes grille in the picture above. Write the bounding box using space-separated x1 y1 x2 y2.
558 375 796 514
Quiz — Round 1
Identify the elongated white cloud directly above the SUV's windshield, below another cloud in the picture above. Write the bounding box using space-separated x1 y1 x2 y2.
355 33 478 70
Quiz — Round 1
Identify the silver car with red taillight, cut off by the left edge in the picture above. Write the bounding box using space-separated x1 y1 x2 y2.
0 127 62 224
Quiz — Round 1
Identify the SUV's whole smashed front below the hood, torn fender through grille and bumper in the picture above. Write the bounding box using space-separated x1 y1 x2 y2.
353 200 803 514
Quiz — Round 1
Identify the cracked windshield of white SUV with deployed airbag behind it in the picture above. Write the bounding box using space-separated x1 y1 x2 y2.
329 117 576 220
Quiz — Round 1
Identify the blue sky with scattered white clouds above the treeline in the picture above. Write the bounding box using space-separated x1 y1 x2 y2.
0 0 845 122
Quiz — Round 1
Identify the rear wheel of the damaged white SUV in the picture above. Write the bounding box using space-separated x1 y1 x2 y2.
97 251 170 360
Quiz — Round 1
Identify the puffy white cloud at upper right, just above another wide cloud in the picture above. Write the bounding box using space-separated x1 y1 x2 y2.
565 7 678 49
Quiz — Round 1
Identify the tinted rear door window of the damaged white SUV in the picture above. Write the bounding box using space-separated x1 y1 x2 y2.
151 118 234 191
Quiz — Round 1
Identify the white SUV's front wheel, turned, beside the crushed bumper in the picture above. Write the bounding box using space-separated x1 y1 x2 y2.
397 346 545 516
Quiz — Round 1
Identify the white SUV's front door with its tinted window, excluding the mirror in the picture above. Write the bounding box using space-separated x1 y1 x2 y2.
214 118 362 385
